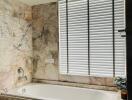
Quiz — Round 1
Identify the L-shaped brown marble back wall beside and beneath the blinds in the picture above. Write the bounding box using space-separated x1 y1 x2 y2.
32 3 113 86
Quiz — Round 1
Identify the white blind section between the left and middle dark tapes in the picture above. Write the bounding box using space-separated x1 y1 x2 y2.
68 0 88 75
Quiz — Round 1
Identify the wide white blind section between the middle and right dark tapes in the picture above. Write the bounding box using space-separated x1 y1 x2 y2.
89 0 113 76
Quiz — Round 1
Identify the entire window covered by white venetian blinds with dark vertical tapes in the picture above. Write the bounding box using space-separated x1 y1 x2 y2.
59 0 126 77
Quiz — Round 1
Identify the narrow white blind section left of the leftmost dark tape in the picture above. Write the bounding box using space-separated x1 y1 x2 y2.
59 0 68 74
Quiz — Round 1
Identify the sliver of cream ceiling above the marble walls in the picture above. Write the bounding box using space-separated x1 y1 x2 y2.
20 0 57 6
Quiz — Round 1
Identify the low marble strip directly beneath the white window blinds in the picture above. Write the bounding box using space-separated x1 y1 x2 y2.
59 75 115 87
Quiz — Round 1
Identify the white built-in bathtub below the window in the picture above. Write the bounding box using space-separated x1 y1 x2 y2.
7 83 120 100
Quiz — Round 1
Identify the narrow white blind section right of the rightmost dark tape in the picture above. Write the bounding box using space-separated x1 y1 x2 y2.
114 0 126 76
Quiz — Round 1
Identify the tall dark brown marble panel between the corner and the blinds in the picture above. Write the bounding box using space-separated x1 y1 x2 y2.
32 3 59 80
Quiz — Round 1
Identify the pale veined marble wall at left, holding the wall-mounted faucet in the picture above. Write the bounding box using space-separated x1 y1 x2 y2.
0 0 32 90
